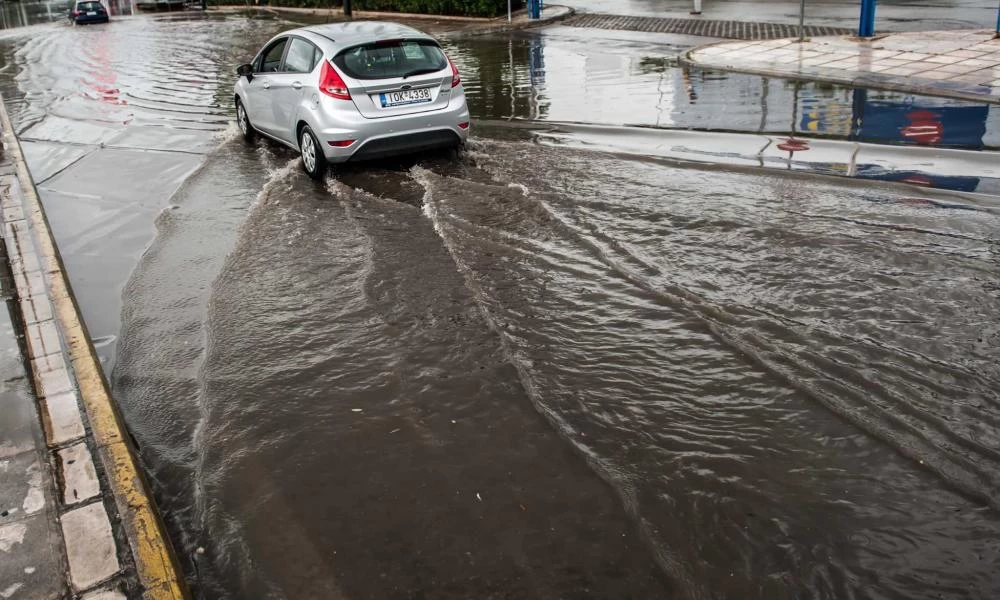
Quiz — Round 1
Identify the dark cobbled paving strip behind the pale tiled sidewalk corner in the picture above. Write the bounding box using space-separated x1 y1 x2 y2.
561 14 853 40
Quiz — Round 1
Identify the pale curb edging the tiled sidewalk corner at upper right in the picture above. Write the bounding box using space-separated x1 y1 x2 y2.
678 38 1000 104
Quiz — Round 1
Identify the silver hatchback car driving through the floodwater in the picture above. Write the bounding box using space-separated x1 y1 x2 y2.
235 21 469 179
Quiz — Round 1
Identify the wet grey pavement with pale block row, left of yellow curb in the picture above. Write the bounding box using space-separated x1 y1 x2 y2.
0 135 127 600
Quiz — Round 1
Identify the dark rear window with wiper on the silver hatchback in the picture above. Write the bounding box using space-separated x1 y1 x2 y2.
333 40 448 79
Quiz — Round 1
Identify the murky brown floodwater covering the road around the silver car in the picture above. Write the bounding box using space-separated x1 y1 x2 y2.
0 9 1000 599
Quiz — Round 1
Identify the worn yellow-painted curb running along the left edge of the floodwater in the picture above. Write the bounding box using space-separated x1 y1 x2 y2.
0 97 190 600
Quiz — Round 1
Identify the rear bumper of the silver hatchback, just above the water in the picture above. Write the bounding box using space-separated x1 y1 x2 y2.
314 95 469 163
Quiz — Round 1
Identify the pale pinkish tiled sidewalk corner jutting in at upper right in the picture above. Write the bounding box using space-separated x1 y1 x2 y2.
683 30 1000 103
